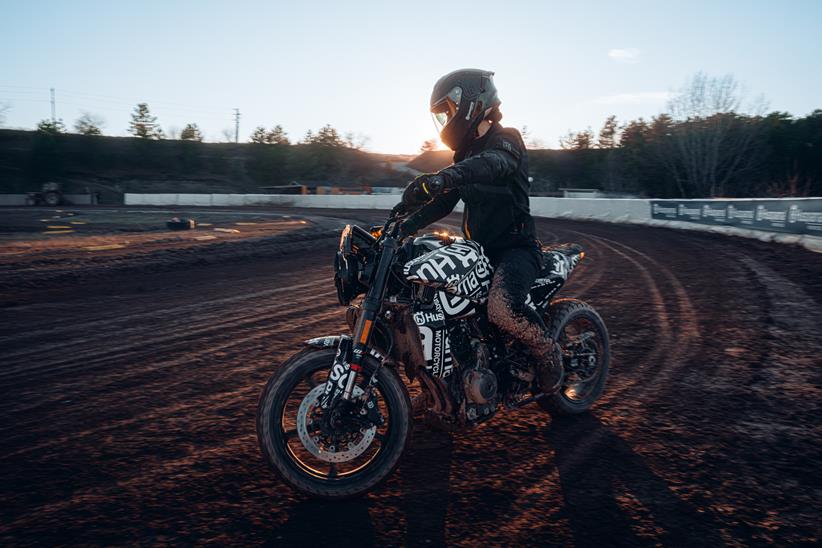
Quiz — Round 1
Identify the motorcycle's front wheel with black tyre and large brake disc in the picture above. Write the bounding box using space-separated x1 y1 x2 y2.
257 348 412 499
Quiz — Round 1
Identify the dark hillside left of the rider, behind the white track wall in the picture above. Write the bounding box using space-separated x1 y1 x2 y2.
0 130 413 199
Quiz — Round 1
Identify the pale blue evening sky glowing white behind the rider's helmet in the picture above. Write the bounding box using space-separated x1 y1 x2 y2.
0 0 822 154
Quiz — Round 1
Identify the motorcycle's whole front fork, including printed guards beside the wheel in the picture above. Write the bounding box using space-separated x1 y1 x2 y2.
324 238 398 407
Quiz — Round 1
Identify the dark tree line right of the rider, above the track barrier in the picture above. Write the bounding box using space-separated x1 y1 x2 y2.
552 73 822 198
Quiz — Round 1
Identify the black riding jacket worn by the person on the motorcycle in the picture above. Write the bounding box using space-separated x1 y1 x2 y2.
406 124 536 254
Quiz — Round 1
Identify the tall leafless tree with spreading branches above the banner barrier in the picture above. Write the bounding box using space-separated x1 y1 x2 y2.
655 73 764 197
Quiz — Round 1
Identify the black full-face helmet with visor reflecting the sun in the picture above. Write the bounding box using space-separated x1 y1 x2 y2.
431 69 500 151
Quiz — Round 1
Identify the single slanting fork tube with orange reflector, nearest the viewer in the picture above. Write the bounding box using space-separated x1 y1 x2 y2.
342 238 397 400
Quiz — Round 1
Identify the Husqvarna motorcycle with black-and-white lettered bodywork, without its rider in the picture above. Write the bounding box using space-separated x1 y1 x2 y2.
257 205 610 498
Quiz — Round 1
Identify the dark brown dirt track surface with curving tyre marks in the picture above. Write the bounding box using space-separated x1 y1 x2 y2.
0 210 822 546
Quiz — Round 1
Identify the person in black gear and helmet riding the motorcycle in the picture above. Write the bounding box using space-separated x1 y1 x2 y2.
402 69 562 392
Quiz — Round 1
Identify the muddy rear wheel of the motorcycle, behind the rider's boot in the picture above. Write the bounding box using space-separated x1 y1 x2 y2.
539 299 611 416
